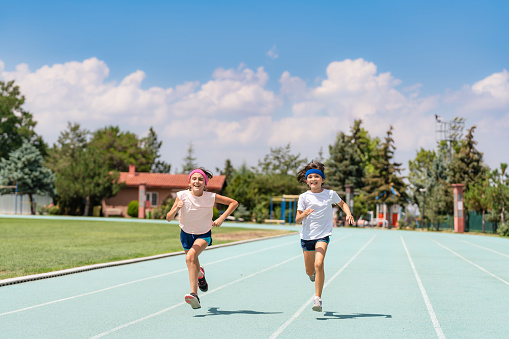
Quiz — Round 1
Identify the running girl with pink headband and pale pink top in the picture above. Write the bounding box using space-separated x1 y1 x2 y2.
166 168 239 308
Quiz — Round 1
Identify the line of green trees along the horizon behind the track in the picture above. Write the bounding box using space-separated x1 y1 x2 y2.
0 81 509 236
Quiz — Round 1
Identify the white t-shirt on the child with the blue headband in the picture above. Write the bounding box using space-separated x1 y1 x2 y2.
297 189 341 240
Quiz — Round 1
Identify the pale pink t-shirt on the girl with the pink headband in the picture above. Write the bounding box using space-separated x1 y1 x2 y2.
177 190 216 234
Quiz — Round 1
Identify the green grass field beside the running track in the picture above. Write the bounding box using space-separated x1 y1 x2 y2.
0 218 287 279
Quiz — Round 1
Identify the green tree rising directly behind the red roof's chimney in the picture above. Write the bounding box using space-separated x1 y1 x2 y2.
90 126 155 172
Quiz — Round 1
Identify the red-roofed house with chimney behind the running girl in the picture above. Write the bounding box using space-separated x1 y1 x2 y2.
102 165 226 218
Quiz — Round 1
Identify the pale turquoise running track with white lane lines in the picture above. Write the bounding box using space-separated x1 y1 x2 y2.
0 228 509 338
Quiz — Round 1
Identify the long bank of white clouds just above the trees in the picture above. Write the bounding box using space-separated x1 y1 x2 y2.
0 57 509 173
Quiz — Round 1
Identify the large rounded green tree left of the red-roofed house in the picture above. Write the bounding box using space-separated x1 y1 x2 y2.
47 123 122 215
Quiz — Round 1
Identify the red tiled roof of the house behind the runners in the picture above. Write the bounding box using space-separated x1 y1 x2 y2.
119 172 226 191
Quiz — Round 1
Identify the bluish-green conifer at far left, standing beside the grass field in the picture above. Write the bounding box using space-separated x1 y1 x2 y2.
0 141 55 214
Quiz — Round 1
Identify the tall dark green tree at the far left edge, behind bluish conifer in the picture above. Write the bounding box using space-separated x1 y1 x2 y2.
0 81 47 158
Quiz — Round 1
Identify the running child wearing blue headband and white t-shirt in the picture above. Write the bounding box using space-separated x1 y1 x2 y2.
295 162 354 312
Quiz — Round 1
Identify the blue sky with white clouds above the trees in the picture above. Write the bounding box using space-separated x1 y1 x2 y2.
0 0 509 172
